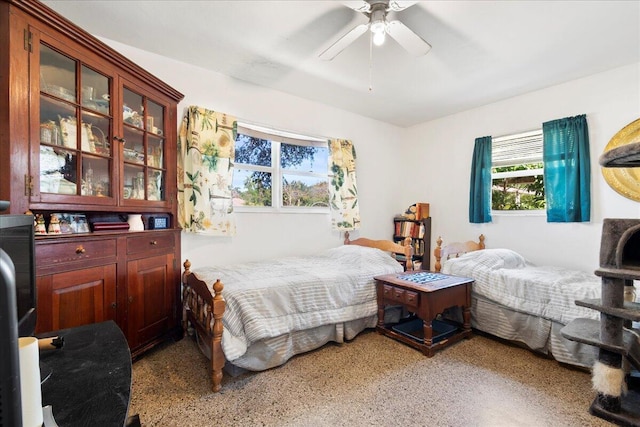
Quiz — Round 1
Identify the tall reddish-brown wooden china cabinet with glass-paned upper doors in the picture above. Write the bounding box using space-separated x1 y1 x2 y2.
0 0 183 357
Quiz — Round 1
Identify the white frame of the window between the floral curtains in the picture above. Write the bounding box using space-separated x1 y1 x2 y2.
233 122 330 215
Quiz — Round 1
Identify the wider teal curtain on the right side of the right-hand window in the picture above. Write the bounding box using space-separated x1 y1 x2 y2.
542 114 591 222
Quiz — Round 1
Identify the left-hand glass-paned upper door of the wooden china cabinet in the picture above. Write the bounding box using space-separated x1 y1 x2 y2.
39 43 113 197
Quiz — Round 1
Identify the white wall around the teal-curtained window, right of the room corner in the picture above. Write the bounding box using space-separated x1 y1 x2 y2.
403 63 640 271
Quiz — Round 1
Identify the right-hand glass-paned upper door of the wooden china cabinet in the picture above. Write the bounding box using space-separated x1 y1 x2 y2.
122 87 166 201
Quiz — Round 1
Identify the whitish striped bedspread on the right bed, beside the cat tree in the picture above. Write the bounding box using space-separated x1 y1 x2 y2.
442 249 601 325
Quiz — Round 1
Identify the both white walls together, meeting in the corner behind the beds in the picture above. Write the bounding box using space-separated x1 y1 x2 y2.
103 39 640 271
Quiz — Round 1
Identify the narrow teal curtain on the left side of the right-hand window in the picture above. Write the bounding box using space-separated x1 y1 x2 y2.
469 136 491 224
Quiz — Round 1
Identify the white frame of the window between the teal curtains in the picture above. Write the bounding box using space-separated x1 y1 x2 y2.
491 128 546 216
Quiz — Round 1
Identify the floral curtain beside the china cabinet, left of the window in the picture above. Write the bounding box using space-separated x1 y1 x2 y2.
178 106 237 236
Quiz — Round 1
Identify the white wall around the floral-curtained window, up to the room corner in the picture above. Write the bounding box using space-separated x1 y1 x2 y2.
102 39 404 267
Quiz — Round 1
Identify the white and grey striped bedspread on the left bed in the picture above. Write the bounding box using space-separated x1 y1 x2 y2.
194 245 403 361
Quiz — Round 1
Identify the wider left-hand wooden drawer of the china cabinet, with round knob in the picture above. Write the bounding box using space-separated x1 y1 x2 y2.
36 239 116 266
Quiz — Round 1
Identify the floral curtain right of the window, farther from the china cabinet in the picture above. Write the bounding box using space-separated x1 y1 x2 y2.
329 139 360 230
